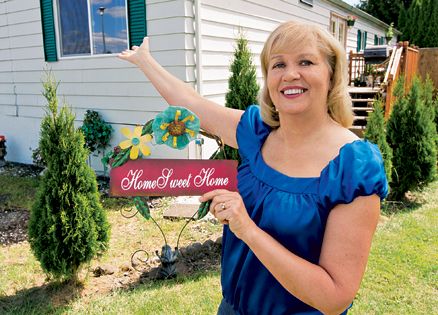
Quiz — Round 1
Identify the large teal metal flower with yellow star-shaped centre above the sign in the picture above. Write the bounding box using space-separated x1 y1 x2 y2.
152 106 200 150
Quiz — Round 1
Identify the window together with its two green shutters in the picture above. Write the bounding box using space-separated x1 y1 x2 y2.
40 0 147 61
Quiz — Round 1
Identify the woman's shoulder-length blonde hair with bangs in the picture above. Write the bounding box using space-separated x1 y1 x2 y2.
260 21 353 128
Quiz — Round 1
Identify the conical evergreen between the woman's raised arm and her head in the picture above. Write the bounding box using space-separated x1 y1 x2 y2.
216 33 259 161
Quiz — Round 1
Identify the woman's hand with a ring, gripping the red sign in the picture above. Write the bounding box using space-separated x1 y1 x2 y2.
199 189 256 239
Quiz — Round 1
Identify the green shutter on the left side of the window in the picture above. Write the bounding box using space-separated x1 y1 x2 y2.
40 0 58 61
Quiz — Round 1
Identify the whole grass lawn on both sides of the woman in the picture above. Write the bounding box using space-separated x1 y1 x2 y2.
0 168 438 315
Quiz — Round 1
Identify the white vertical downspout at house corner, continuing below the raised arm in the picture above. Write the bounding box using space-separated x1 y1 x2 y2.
193 0 204 159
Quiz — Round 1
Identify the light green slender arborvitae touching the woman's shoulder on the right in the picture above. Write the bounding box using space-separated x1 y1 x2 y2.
364 99 392 182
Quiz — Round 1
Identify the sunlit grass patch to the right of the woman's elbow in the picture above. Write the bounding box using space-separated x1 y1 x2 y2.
351 182 438 314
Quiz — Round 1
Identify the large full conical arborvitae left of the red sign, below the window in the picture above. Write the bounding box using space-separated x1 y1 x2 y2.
29 73 109 280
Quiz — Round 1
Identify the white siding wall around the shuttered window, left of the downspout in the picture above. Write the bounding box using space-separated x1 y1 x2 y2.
0 0 195 170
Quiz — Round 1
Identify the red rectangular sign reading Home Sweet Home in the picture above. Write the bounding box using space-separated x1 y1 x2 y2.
110 159 237 197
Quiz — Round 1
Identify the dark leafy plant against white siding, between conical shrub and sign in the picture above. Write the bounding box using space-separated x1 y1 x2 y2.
81 110 113 152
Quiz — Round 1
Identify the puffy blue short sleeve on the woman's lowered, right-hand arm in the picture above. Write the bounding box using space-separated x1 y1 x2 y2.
319 140 388 209
